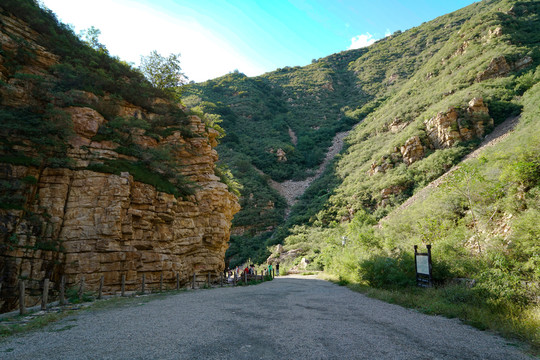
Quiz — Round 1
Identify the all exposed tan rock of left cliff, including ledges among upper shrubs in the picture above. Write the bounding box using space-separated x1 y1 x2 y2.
0 10 239 311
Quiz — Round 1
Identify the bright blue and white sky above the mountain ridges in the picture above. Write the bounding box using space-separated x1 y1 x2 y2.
42 0 475 82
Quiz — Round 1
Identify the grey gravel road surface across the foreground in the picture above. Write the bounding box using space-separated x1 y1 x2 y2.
0 276 532 360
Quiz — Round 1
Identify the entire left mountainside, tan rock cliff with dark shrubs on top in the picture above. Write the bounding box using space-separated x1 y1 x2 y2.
0 0 239 311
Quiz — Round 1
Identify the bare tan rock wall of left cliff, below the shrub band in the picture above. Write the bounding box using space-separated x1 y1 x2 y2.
0 112 239 310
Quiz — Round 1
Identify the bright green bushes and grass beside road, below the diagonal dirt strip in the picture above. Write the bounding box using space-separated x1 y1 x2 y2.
284 84 540 351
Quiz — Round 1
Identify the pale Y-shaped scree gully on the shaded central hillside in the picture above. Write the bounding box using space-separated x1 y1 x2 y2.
269 131 349 209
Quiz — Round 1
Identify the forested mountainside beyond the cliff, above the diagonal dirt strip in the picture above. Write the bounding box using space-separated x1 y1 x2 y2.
185 1 538 260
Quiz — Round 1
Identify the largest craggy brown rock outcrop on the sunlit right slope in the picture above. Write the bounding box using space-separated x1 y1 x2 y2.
425 98 493 149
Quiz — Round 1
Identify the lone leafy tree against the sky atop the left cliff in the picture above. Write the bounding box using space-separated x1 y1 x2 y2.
139 50 188 93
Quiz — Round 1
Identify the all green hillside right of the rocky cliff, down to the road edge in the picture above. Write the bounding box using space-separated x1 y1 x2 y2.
185 0 540 345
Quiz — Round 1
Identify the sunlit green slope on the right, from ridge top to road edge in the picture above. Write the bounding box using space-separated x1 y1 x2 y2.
269 1 540 349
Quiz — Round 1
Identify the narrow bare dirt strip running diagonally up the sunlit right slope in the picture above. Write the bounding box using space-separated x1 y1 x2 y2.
381 116 520 222
